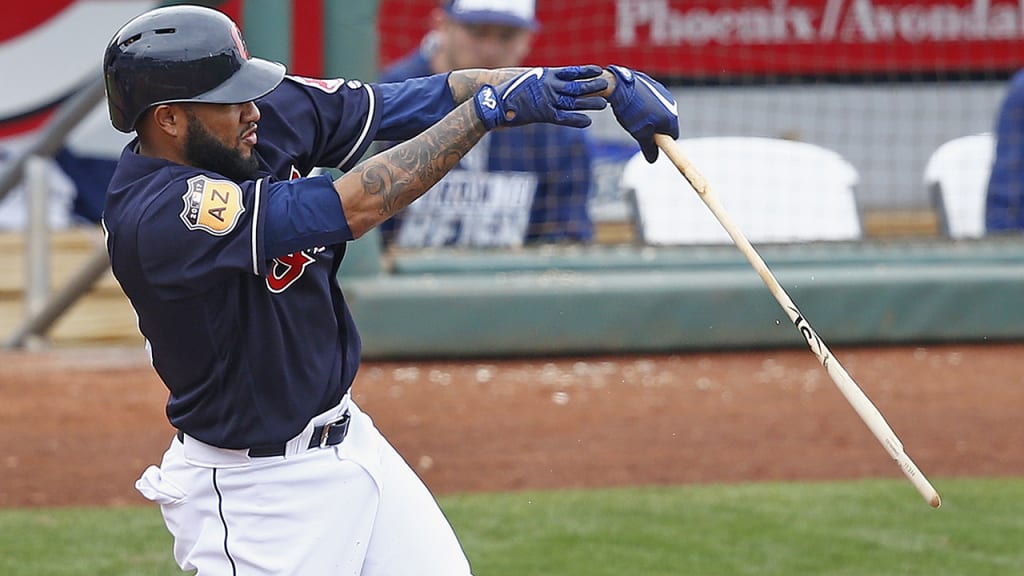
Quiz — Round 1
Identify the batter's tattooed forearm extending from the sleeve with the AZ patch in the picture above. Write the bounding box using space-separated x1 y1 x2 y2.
334 99 483 238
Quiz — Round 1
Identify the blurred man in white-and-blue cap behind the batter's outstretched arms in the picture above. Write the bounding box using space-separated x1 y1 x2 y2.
380 0 593 248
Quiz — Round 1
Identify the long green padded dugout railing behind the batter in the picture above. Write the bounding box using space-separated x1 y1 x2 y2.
342 238 1024 358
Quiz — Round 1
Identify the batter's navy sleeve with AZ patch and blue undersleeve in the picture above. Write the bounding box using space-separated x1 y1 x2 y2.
138 174 352 299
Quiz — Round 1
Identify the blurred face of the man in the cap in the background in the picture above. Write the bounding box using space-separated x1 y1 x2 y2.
441 20 532 70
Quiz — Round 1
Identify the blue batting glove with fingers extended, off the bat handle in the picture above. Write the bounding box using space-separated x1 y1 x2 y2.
473 66 608 130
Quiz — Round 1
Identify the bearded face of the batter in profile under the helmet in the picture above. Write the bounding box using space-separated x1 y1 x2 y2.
184 102 259 181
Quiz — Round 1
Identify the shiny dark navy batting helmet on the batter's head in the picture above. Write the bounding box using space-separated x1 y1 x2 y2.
103 6 285 132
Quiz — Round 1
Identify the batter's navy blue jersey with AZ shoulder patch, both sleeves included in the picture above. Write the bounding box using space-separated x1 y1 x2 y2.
103 75 454 449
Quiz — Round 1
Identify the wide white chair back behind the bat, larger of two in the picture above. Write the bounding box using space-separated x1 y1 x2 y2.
621 136 862 245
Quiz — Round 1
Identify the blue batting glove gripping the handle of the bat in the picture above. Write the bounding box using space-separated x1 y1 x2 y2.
608 66 679 164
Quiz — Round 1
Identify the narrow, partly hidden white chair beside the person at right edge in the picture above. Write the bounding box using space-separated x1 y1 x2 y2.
925 132 995 239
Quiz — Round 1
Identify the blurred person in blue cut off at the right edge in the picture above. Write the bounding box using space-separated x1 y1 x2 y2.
985 70 1024 234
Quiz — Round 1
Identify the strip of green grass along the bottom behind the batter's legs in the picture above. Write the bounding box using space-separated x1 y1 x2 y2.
0 479 1024 576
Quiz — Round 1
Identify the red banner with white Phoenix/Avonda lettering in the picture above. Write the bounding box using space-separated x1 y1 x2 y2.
379 0 1024 77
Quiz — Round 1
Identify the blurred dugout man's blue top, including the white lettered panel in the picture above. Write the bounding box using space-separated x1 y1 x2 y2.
381 42 593 247
